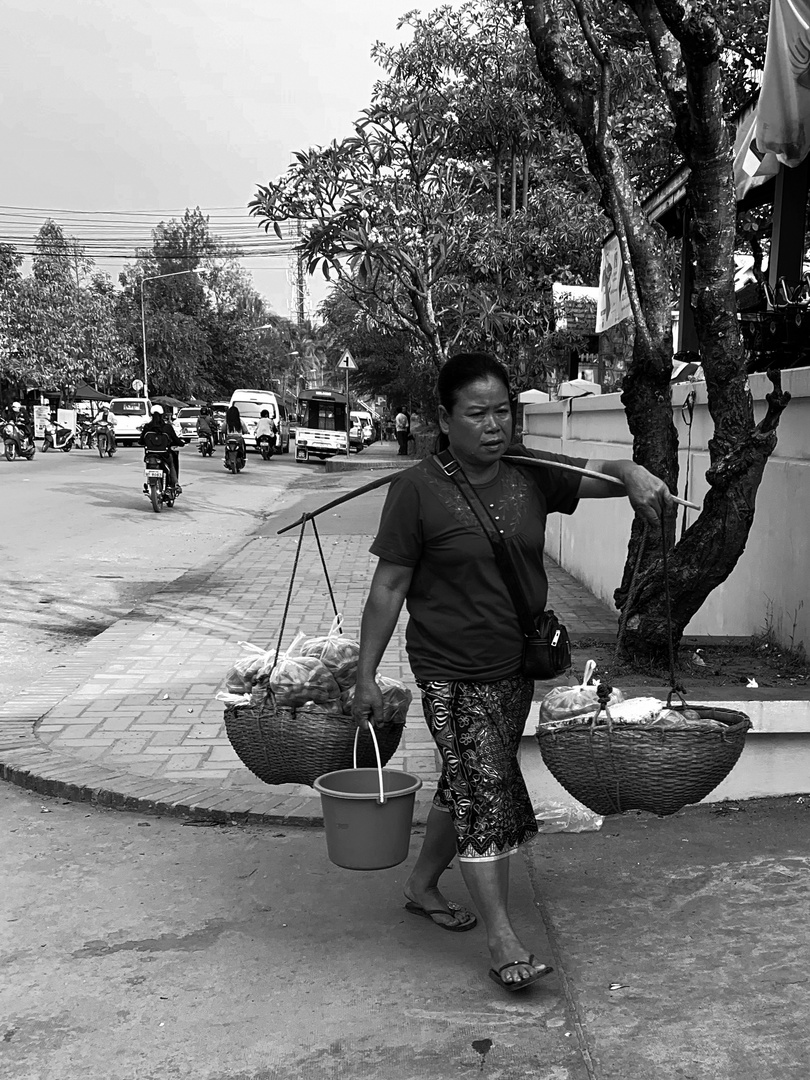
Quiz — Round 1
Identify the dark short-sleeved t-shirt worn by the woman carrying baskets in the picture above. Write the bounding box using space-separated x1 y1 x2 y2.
370 451 585 683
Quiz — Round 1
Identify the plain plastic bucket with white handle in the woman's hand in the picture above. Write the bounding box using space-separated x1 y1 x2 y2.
313 727 422 870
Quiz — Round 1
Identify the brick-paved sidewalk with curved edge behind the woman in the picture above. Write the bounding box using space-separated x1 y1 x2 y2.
0 444 616 824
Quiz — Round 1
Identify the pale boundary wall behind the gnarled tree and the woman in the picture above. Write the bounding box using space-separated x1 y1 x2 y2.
524 367 810 652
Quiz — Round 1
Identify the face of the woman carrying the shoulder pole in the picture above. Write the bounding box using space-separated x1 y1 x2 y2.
438 377 512 467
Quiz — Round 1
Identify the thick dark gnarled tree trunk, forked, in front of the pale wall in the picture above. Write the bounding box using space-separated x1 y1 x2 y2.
523 0 789 659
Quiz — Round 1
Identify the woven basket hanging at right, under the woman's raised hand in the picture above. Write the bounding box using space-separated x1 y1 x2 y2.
537 705 751 818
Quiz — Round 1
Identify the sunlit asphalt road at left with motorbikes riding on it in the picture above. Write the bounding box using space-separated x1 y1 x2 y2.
0 444 313 701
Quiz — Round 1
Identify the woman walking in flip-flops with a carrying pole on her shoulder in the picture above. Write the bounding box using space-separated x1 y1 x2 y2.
353 353 672 990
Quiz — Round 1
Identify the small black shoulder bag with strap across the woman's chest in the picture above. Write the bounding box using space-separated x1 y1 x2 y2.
435 450 571 679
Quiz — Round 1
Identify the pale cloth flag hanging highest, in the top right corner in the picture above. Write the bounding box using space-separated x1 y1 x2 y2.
756 0 810 168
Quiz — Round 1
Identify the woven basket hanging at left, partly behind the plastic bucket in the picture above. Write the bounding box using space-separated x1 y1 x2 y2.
225 699 403 787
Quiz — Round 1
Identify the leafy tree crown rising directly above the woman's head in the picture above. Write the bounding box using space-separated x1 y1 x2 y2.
251 0 606 388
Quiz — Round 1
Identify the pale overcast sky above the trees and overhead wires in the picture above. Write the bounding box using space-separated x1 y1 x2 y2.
0 0 457 313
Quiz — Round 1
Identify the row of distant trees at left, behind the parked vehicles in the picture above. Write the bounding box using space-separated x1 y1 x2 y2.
0 207 306 400
